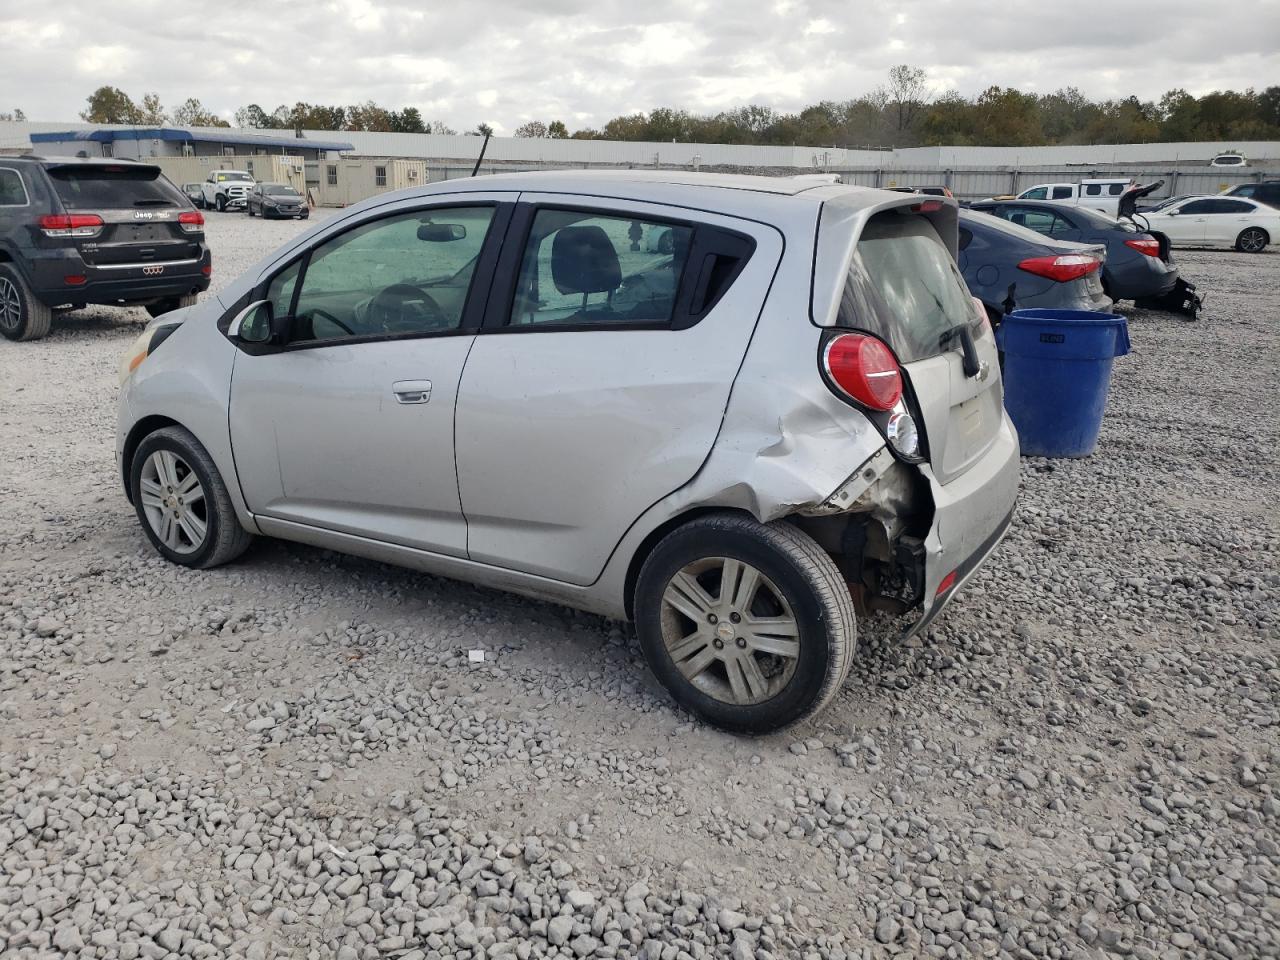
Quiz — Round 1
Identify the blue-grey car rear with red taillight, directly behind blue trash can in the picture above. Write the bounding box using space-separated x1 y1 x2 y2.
959 209 1111 325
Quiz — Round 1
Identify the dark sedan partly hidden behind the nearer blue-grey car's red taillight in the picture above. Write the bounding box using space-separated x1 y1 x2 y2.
970 200 1178 300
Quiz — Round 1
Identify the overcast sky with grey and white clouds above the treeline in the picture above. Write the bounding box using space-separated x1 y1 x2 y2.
0 0 1280 133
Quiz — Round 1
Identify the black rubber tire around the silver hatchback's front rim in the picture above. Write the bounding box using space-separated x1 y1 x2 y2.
129 426 253 570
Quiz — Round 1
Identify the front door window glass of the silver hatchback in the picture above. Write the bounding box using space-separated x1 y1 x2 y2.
289 206 493 340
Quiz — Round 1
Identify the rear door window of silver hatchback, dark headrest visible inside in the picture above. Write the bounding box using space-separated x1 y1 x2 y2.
511 210 692 325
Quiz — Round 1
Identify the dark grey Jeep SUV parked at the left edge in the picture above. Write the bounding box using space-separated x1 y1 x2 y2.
0 156 211 340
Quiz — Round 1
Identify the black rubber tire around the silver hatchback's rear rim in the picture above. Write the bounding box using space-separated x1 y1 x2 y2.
635 513 858 735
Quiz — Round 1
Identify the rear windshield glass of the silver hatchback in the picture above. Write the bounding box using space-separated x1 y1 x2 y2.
838 212 979 364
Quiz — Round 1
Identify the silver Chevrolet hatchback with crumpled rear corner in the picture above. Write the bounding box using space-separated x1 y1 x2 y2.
116 172 1019 733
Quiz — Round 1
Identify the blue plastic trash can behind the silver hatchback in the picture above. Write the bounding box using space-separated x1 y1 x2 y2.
996 310 1129 457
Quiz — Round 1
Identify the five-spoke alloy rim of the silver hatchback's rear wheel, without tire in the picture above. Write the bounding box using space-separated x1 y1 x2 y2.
660 557 800 705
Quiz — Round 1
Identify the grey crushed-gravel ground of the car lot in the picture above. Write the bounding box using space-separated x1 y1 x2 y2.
0 214 1280 960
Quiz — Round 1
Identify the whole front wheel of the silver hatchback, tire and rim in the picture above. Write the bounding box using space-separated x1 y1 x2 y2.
129 426 253 568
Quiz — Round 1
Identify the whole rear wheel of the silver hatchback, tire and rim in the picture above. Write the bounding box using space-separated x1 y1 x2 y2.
635 513 856 735
